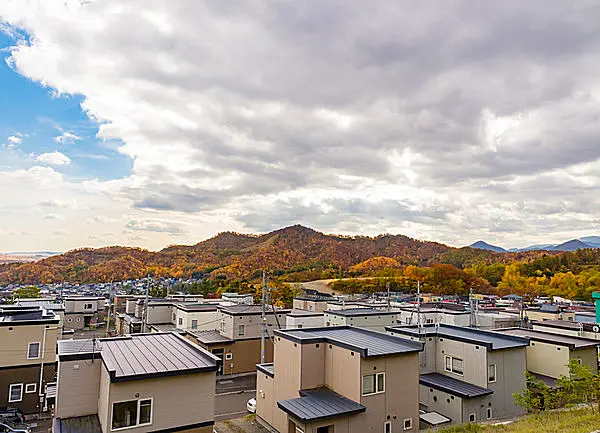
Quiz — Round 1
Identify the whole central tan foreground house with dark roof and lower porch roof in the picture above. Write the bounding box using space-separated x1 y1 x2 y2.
256 326 423 433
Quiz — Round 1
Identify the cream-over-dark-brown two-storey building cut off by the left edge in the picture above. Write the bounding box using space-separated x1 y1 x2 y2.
0 306 60 414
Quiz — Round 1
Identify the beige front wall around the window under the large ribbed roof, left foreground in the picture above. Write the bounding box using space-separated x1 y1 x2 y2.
99 372 215 433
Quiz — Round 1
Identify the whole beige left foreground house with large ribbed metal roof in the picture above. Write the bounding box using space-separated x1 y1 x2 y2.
53 333 217 433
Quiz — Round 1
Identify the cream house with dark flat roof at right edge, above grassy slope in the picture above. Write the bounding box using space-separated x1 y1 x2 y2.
498 328 600 386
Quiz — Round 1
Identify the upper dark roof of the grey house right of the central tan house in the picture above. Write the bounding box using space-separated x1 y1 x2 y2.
385 324 529 351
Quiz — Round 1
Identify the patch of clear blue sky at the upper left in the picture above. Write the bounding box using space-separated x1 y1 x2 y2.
0 32 132 180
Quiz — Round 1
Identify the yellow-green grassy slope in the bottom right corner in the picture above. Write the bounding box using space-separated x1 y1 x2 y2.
439 409 600 433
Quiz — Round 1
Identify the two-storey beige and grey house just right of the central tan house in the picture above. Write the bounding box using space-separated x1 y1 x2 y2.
387 325 529 428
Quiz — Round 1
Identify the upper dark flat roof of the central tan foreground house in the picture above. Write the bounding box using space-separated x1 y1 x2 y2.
275 326 423 358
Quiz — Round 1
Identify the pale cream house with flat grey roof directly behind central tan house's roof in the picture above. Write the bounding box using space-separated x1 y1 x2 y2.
325 308 398 331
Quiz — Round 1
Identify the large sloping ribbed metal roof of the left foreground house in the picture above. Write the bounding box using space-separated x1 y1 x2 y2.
100 332 218 382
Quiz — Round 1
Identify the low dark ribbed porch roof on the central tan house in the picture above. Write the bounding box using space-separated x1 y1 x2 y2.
277 388 366 422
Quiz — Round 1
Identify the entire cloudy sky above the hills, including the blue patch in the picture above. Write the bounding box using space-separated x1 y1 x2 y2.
0 0 600 252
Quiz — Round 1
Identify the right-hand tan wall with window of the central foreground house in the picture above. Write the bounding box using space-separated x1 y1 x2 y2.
350 353 419 433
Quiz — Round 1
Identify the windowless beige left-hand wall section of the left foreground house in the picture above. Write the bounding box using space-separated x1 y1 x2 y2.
54 359 102 418
